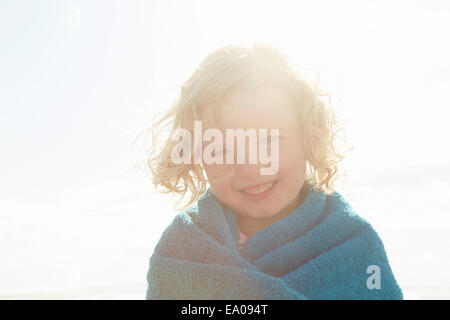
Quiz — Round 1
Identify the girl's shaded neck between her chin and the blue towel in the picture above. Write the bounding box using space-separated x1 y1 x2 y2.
236 182 308 238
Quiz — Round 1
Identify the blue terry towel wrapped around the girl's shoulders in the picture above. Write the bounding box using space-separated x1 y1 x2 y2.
146 184 403 300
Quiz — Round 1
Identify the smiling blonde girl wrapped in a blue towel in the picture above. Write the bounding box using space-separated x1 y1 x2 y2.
147 44 403 299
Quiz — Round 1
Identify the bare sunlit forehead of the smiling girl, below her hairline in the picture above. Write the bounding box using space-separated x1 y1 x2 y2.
202 87 299 133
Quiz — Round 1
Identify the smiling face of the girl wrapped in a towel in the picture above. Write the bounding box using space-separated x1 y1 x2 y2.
202 87 306 224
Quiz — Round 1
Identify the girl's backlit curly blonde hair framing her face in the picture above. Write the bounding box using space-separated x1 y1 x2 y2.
139 42 345 209
